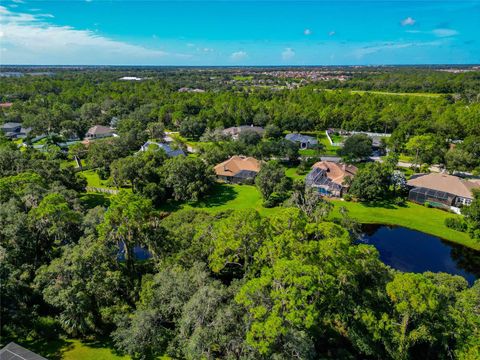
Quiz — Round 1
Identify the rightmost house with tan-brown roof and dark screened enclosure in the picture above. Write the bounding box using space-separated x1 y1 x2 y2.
407 173 480 209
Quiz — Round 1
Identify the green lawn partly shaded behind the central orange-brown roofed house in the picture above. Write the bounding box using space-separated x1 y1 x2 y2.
163 184 279 216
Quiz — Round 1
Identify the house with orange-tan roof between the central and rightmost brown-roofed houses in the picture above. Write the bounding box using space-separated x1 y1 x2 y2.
305 161 358 197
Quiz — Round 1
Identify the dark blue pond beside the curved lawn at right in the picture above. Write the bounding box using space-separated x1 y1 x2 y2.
359 224 480 284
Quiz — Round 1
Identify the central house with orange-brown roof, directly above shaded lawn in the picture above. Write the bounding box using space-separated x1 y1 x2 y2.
214 156 260 184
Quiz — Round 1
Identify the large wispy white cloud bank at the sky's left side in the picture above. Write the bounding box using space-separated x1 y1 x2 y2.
0 6 189 65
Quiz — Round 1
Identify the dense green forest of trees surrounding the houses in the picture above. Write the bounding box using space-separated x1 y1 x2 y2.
0 68 480 360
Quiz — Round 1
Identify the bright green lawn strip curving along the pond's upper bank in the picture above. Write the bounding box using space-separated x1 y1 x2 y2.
331 200 480 250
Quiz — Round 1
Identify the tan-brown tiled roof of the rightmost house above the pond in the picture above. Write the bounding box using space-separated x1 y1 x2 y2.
407 173 480 199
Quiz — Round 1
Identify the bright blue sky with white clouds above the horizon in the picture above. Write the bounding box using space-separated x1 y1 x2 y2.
0 0 480 65
